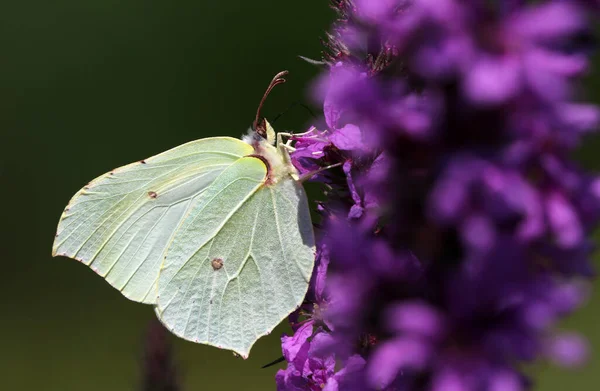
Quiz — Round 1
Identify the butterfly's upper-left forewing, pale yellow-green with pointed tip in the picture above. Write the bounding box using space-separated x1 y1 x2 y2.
52 137 253 304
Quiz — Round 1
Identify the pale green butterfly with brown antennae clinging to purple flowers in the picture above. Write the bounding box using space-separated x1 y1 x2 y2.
52 72 315 358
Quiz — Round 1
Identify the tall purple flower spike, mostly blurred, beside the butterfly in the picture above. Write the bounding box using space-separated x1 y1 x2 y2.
277 0 600 391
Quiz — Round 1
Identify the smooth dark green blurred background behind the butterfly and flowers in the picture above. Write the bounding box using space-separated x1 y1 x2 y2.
0 0 600 391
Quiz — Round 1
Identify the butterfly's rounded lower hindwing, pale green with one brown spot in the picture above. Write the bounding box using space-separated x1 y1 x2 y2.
156 157 315 357
